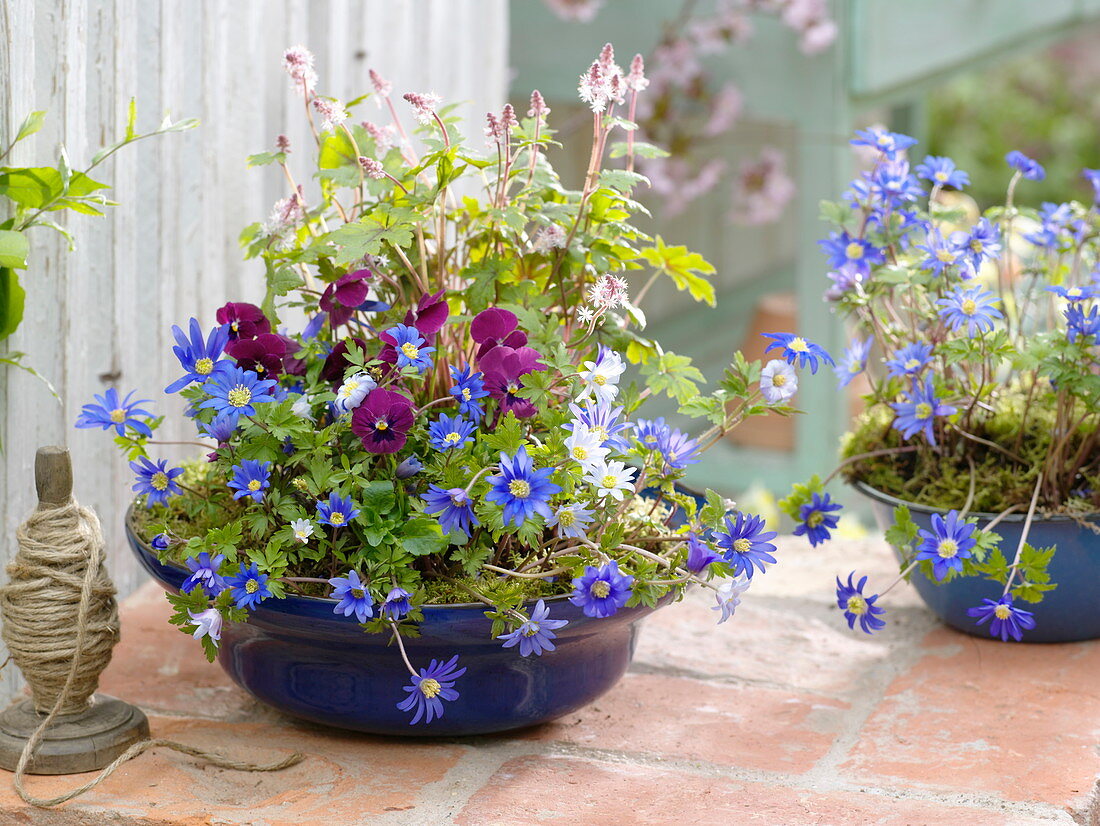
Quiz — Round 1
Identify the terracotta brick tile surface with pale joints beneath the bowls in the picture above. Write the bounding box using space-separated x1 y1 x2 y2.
0 539 1100 826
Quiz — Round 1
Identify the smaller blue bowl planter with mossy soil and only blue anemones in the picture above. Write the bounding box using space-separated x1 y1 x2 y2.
854 482 1100 642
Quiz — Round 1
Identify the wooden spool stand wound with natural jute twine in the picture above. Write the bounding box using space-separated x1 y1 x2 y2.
0 447 150 774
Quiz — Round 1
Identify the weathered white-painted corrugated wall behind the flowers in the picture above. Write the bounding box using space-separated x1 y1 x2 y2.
0 0 507 693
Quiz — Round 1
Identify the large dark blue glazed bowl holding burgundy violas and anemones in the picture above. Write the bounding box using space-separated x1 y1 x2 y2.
125 518 671 737
